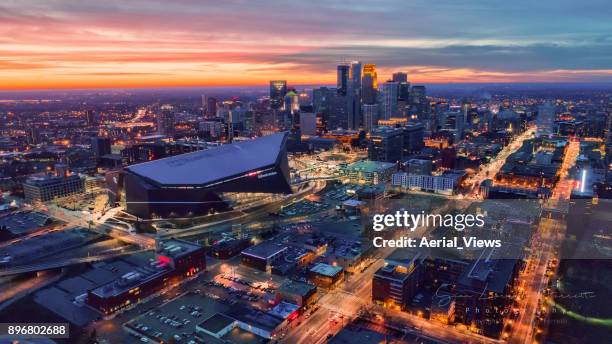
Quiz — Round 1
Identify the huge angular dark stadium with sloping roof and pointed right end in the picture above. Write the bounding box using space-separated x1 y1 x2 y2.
124 133 292 219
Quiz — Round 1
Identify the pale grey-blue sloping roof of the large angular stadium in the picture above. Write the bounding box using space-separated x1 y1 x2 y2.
127 133 287 185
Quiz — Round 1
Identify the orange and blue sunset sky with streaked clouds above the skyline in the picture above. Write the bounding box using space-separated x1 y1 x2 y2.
0 0 612 90
